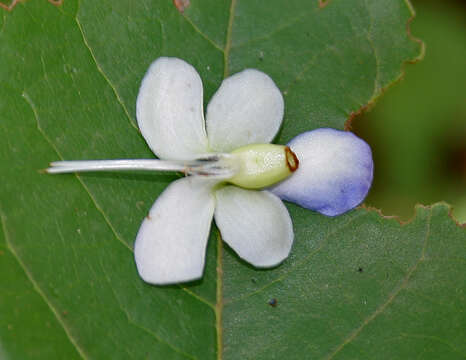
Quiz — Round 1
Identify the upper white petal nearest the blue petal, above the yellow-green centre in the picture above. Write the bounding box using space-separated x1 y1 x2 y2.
206 69 284 152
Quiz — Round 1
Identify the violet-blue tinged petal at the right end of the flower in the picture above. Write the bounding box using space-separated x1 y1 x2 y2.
270 128 374 216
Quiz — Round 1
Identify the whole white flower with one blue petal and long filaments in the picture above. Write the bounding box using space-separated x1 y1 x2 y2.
47 57 373 285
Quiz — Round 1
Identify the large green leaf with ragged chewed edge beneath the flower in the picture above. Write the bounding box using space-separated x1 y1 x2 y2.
0 0 466 359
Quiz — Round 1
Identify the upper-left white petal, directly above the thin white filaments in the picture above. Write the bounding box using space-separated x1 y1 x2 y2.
136 57 207 160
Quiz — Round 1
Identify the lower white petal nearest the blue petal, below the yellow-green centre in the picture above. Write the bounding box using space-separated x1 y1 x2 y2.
215 186 294 267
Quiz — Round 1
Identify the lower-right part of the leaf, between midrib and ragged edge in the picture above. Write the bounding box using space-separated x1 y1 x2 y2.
223 204 466 359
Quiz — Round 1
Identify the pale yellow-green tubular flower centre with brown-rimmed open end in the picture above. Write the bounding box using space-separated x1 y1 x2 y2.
228 144 299 189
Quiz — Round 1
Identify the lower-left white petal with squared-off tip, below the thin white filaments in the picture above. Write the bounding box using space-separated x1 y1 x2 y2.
134 177 215 285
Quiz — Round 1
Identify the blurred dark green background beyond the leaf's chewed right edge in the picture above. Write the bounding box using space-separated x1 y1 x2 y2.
352 0 466 222
